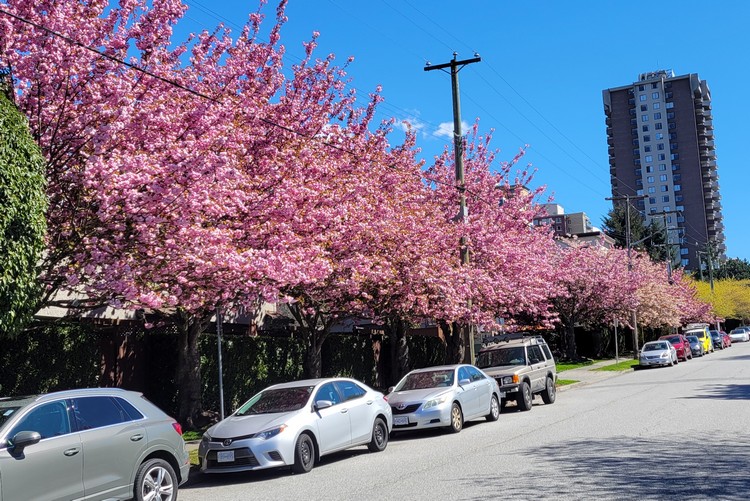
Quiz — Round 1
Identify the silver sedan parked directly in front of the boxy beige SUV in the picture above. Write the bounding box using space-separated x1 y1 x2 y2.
388 364 503 433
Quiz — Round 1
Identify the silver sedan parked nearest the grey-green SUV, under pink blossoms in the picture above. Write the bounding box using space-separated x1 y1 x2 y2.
198 378 393 473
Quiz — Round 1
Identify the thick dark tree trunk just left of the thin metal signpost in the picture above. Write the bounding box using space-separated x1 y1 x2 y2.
175 311 210 430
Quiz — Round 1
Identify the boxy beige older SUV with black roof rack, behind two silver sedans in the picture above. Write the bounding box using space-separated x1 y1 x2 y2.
476 333 557 411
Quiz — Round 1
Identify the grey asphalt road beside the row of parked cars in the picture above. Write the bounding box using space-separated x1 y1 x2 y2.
179 343 750 501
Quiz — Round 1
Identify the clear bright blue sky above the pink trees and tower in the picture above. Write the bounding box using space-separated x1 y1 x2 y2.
179 0 750 259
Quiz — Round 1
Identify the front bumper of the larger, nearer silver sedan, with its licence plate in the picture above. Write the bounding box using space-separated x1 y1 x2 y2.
198 437 294 473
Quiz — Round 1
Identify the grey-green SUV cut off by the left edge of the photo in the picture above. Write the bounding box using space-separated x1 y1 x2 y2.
0 388 190 501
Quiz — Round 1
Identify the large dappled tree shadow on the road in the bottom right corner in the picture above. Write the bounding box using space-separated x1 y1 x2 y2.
457 430 750 500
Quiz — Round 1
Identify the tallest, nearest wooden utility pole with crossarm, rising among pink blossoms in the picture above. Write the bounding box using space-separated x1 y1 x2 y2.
424 52 482 364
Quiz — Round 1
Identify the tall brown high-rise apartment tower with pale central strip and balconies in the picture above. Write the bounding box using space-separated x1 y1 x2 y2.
603 70 726 270
